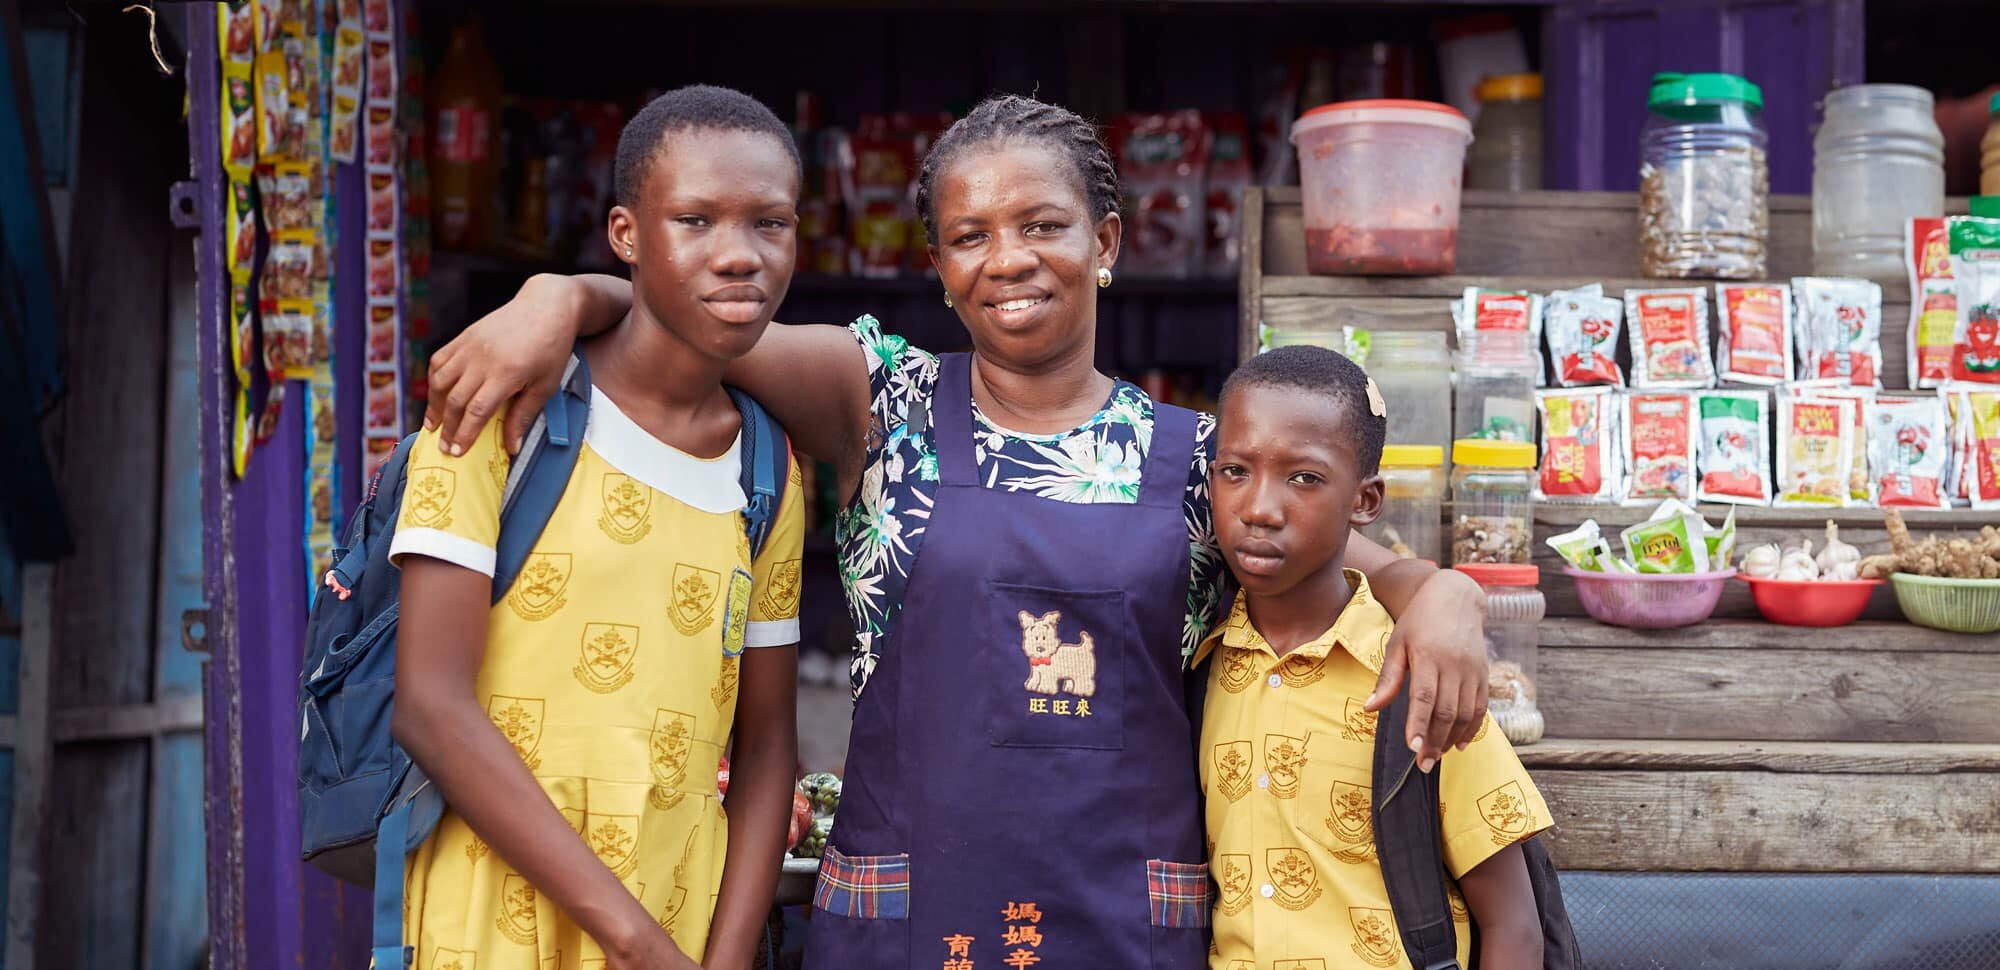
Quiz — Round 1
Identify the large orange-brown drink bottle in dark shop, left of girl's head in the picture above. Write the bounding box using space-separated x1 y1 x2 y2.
430 20 500 252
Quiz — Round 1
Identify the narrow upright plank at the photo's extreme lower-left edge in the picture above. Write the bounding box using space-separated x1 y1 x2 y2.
0 564 51 970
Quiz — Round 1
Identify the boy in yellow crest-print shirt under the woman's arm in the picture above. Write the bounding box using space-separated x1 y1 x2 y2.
1196 346 1550 970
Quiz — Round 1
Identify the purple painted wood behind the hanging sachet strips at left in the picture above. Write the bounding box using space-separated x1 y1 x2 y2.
186 2 368 970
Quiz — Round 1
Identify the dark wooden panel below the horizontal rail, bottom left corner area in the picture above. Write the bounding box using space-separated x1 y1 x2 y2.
37 740 150 968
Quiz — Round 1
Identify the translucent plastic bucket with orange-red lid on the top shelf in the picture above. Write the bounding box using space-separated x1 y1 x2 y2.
1292 100 1472 276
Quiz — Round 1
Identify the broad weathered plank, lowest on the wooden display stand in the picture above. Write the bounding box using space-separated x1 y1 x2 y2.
1534 770 2000 872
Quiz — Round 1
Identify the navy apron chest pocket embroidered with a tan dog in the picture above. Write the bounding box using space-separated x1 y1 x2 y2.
974 582 1134 750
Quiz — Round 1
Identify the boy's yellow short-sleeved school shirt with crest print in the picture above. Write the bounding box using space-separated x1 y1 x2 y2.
1194 570 1550 970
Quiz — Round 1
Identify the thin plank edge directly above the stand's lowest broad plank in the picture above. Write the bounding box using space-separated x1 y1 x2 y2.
1516 738 2000 774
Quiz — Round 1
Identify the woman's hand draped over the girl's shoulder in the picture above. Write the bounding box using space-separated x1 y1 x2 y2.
424 272 632 454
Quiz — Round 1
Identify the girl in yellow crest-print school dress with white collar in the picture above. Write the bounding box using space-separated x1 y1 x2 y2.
392 86 804 970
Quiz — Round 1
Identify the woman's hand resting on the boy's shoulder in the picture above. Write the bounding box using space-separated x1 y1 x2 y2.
1368 570 1486 772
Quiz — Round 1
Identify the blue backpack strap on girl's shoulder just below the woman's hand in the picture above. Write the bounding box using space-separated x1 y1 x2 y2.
492 348 590 602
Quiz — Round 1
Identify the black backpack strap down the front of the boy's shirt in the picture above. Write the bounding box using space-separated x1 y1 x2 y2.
1372 688 1460 970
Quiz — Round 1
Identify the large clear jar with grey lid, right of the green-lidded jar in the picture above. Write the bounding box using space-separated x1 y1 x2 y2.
1812 84 1944 280
